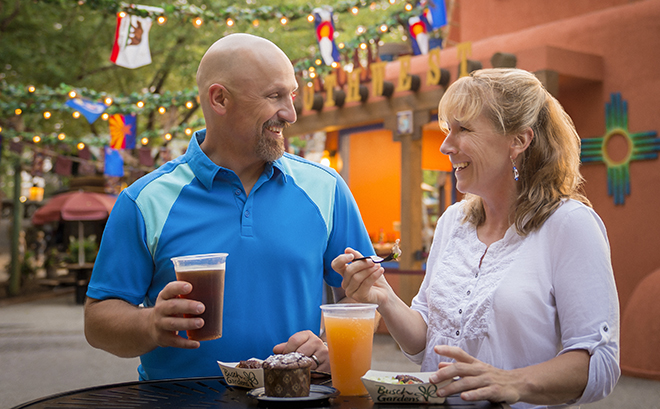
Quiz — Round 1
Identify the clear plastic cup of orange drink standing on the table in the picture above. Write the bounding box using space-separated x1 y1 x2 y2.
321 304 378 396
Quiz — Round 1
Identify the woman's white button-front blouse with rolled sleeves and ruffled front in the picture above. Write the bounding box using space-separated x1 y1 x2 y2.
409 200 620 408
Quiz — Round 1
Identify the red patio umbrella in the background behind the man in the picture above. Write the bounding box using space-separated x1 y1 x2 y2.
32 190 117 265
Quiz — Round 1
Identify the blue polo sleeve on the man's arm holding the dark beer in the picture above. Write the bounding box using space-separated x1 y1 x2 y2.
87 190 154 305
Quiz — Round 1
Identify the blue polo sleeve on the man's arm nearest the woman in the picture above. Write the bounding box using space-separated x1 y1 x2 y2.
323 174 376 287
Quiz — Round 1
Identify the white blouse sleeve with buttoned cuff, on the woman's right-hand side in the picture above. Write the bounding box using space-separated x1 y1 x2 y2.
552 205 621 404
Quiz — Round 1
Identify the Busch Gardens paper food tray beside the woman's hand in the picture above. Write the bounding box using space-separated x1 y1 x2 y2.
362 371 451 404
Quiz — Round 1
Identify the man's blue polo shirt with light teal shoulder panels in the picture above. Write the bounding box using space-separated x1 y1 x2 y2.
87 130 374 380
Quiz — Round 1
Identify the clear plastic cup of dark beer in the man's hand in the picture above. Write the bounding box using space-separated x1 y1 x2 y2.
172 253 228 341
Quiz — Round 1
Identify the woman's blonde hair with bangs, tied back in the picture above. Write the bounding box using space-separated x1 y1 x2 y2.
438 68 591 235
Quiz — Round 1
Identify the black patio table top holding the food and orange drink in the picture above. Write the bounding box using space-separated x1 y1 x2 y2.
13 376 510 409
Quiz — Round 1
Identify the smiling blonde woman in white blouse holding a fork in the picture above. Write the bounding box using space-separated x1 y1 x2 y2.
333 69 620 408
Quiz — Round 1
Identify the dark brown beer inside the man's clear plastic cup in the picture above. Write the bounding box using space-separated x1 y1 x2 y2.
176 269 225 341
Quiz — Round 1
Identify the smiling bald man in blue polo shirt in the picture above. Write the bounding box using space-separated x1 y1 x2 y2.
85 34 374 380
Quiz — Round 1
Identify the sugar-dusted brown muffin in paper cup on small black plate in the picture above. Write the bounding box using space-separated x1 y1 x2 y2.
263 352 314 398
